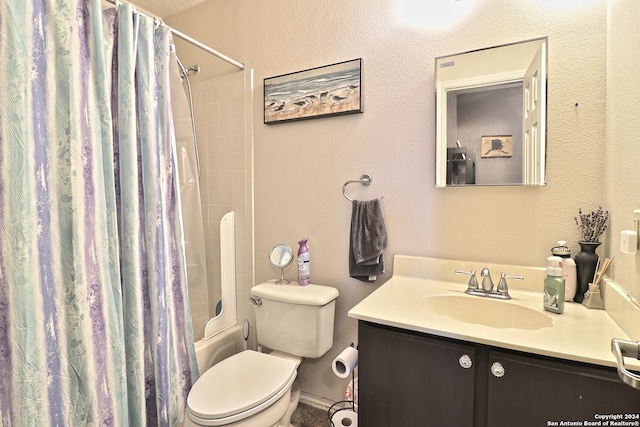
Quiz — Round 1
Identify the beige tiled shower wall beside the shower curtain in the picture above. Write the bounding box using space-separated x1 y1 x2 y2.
192 70 254 340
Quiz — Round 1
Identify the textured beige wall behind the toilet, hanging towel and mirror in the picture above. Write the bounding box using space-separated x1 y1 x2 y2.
167 0 616 406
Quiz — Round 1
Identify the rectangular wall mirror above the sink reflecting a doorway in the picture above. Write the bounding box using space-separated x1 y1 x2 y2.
435 37 547 187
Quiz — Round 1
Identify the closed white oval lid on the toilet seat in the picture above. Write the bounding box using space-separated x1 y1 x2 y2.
187 350 297 419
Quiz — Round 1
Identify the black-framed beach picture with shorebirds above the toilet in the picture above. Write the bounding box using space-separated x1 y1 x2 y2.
264 58 362 125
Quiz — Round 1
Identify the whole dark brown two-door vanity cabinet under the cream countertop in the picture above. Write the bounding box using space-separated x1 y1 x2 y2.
358 321 640 427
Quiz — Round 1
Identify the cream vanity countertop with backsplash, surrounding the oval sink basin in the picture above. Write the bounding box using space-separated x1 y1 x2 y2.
348 256 640 369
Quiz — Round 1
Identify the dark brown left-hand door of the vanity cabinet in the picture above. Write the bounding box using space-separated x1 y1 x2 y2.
358 321 476 427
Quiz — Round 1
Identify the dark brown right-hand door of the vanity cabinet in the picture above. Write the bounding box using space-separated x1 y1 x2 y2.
487 351 640 427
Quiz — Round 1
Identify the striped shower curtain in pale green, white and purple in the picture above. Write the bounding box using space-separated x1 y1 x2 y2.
0 0 198 427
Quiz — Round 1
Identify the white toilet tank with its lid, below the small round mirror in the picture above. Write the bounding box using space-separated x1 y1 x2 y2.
250 280 338 358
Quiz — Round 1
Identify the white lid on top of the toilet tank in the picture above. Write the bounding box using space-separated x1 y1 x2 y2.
250 280 339 305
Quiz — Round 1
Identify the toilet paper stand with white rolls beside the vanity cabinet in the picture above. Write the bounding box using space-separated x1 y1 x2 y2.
327 343 358 427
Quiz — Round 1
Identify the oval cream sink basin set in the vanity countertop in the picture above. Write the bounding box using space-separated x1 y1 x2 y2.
421 295 553 330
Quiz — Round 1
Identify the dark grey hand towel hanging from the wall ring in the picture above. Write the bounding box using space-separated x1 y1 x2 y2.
349 199 387 282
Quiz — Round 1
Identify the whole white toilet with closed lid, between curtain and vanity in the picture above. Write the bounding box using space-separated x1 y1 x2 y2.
184 280 338 427
